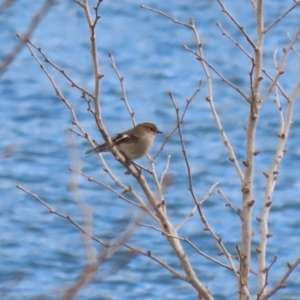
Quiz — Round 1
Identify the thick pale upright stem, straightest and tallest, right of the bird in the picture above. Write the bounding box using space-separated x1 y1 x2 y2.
238 0 264 300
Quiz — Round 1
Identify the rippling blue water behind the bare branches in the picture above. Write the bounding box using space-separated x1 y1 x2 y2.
0 0 300 300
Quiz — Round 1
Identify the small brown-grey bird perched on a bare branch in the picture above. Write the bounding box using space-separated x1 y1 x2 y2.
86 123 162 161
